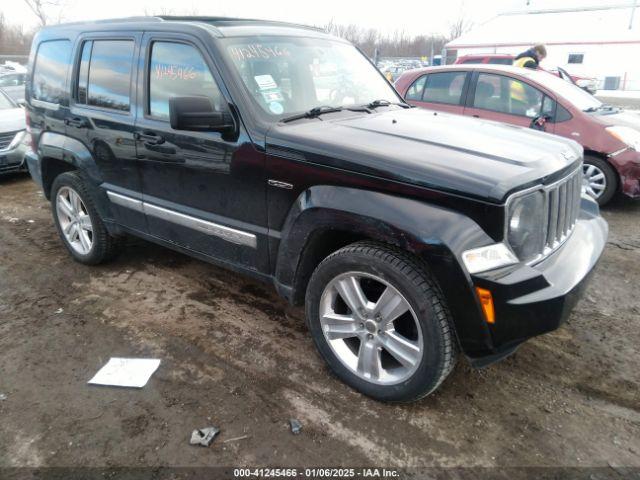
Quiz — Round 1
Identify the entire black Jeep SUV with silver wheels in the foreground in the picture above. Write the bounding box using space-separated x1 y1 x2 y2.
26 17 607 401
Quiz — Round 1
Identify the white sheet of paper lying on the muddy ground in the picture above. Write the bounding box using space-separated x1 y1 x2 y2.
89 358 160 388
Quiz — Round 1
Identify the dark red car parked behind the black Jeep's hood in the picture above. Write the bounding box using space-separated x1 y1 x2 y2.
395 65 640 205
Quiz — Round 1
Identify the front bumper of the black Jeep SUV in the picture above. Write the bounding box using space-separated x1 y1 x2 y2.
470 197 608 366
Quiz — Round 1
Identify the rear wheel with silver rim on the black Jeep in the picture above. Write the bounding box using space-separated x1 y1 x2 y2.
51 172 121 265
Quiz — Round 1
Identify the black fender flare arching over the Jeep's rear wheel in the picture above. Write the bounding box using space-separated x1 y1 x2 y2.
38 131 120 234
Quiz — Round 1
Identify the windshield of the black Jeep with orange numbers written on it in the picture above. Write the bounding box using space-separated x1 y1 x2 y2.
223 37 401 120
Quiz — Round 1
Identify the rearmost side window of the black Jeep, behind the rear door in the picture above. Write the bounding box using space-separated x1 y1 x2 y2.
31 40 71 104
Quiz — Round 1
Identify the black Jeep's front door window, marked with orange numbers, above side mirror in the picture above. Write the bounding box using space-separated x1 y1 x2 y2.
148 42 222 119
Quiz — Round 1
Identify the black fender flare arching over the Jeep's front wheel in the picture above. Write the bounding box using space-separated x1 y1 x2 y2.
275 186 495 357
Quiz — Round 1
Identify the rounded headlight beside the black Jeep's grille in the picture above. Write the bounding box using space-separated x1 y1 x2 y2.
506 191 546 262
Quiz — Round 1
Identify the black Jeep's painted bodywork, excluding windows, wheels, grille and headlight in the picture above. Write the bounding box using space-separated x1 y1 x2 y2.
26 18 606 365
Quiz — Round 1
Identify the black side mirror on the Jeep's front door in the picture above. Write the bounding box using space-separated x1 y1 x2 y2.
169 97 236 134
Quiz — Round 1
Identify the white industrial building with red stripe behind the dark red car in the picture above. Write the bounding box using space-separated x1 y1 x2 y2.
446 1 640 90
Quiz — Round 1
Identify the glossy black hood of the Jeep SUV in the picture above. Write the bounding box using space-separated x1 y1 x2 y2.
266 107 582 202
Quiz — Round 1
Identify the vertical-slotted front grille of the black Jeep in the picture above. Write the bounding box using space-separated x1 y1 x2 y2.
544 167 582 255
